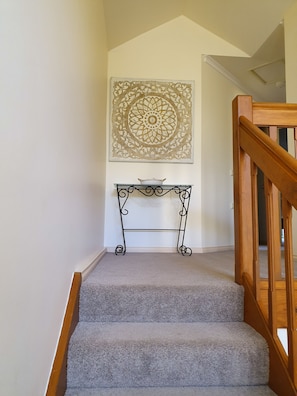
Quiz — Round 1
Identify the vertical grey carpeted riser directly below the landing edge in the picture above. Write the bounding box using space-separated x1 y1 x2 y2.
80 284 243 322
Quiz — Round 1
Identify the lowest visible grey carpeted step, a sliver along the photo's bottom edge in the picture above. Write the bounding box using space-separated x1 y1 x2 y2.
65 385 276 396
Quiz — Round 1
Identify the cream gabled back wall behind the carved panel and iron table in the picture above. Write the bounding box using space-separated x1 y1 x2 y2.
105 17 245 251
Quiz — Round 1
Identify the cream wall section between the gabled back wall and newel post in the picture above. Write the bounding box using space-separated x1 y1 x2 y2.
201 63 246 249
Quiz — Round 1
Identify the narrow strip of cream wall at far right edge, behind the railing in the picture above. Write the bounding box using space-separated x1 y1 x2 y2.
284 3 297 256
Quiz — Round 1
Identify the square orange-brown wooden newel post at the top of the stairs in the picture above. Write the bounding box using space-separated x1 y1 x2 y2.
232 96 253 284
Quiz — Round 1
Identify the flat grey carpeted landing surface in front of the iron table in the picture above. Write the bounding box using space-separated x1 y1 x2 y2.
83 252 238 287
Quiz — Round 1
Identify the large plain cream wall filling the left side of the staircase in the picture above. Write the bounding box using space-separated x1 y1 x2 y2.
0 0 107 396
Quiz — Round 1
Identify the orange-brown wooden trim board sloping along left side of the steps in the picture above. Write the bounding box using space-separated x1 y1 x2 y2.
46 272 82 396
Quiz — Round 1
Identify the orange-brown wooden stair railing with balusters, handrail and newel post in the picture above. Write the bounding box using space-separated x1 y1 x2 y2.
232 96 297 395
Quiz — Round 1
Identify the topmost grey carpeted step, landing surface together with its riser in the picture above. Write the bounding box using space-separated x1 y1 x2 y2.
80 254 244 322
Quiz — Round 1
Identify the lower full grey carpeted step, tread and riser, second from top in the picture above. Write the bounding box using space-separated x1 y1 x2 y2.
68 322 269 389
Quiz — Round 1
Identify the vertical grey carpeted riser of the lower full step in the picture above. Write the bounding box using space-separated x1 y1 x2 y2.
68 342 268 388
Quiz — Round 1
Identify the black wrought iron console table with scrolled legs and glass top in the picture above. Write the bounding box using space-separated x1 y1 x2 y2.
115 184 192 256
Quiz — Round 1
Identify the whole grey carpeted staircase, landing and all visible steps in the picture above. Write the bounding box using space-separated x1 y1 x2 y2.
66 252 275 396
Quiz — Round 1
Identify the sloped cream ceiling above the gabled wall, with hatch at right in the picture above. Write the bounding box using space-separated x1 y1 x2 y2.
103 0 297 102
